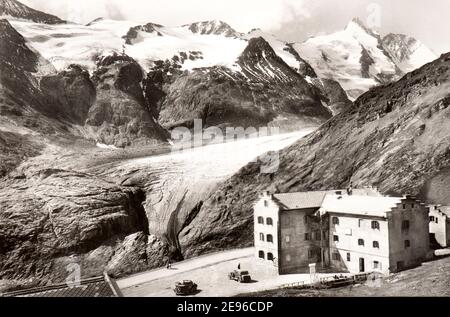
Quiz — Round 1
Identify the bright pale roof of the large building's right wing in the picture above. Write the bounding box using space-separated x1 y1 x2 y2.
320 195 402 217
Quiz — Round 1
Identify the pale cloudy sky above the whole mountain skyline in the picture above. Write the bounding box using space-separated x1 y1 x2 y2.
22 0 450 54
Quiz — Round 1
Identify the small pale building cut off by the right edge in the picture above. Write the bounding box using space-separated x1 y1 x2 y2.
428 206 450 248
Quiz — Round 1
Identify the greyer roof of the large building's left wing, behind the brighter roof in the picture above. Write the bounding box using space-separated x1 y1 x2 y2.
273 188 381 210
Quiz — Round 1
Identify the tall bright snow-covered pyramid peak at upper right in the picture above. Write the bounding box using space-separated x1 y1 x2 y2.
294 19 398 99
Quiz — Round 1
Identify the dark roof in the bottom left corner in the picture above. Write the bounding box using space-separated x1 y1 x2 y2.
0 274 123 297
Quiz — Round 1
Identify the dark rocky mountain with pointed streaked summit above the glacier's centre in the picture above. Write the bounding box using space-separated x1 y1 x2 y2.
153 38 331 129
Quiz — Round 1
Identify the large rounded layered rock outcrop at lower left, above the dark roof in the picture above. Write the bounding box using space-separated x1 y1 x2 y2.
0 169 172 284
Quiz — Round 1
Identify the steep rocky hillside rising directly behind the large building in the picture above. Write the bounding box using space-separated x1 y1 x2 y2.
179 53 450 257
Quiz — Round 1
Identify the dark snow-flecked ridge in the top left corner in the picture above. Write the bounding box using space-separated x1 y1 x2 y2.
0 0 65 24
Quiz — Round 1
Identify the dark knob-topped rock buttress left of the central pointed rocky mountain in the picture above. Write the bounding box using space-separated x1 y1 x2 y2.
86 55 168 147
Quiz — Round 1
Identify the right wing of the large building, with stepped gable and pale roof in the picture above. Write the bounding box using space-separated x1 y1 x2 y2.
320 195 430 273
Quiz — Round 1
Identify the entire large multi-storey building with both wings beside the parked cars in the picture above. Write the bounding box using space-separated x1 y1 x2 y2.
254 189 429 274
